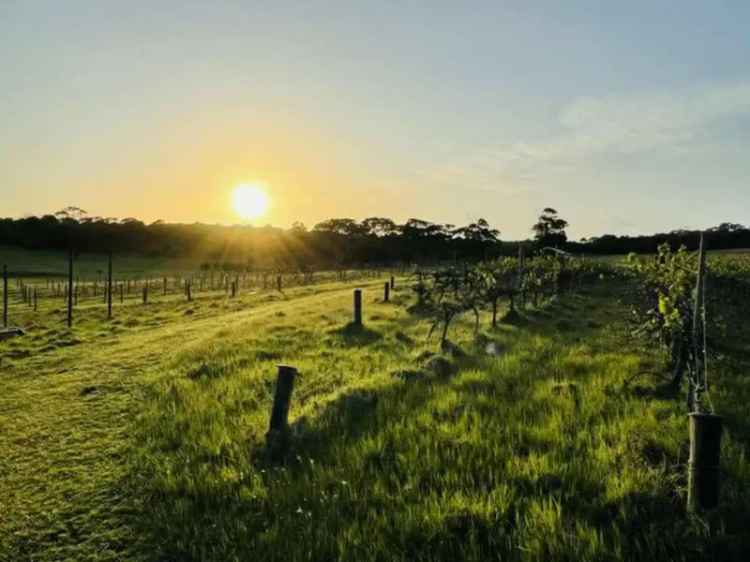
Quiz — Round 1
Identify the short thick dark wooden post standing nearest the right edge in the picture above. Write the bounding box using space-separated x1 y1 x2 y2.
688 413 722 511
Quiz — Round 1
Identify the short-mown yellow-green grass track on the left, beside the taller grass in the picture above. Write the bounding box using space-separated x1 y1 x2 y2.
0 283 390 561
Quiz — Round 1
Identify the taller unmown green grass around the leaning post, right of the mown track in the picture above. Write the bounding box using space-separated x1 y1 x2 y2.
132 287 750 561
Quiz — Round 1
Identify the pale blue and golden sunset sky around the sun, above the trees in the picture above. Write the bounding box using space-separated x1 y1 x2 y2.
0 0 750 239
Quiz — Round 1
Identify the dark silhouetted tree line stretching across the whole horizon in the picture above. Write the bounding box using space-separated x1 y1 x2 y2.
0 207 750 269
